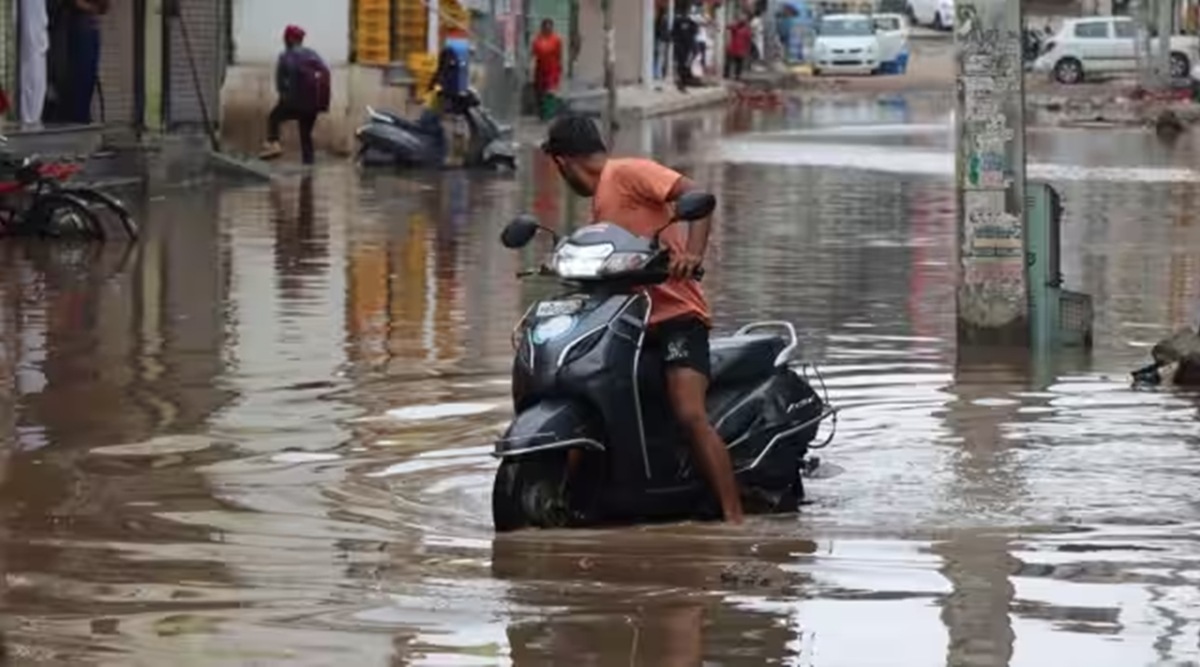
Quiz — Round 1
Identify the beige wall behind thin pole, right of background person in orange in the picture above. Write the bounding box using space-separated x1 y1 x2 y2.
575 0 646 86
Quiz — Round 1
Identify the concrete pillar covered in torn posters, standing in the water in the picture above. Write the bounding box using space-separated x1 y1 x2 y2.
954 0 1030 345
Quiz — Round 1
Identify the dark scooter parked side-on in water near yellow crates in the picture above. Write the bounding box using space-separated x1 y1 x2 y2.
355 91 517 169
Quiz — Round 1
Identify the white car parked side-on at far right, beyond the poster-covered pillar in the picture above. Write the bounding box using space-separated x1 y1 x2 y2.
1033 17 1200 84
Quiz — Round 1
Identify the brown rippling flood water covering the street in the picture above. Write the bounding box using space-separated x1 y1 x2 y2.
0 98 1200 667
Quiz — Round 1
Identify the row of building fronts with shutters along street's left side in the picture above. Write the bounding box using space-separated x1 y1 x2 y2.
0 0 656 151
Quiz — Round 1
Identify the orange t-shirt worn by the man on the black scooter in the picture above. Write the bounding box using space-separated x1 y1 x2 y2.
592 157 712 326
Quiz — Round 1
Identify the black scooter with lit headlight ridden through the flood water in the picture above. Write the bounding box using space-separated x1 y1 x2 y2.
492 193 836 531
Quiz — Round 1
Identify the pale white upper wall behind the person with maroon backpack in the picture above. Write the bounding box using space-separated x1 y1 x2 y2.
233 0 350 66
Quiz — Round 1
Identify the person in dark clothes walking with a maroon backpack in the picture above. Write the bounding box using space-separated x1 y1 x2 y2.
258 25 330 164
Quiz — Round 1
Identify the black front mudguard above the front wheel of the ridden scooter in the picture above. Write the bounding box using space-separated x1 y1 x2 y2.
492 401 606 458
